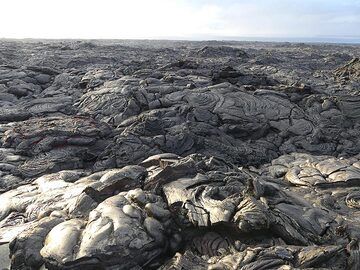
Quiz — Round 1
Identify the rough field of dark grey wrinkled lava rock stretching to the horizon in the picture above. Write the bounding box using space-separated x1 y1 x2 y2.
0 41 360 270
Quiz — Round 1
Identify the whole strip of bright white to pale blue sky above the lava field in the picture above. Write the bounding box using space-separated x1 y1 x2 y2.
0 0 360 39
